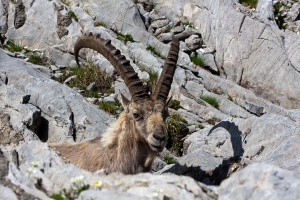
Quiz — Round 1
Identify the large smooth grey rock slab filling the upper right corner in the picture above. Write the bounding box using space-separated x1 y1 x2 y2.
156 0 300 109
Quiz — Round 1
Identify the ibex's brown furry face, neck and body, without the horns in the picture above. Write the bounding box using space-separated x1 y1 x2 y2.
52 99 167 174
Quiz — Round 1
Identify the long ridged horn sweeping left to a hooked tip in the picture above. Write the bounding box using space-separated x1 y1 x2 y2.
74 33 149 102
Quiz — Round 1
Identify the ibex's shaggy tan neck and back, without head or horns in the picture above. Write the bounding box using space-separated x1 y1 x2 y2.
54 112 155 174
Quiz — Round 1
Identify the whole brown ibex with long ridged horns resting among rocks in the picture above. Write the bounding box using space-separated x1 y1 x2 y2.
54 33 179 174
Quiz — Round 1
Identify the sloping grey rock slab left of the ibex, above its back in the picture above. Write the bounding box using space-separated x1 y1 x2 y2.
0 48 112 142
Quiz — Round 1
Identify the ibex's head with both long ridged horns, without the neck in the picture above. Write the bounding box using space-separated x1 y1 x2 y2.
74 33 179 151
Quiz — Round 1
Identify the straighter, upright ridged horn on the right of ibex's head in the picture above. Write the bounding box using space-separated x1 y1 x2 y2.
152 37 179 102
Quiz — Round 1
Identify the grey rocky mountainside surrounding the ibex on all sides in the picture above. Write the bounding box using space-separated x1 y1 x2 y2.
0 0 300 200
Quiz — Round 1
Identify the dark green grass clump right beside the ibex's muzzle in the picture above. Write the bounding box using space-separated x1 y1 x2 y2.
165 114 189 156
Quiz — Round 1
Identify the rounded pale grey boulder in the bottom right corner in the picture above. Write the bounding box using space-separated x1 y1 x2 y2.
216 164 300 200
